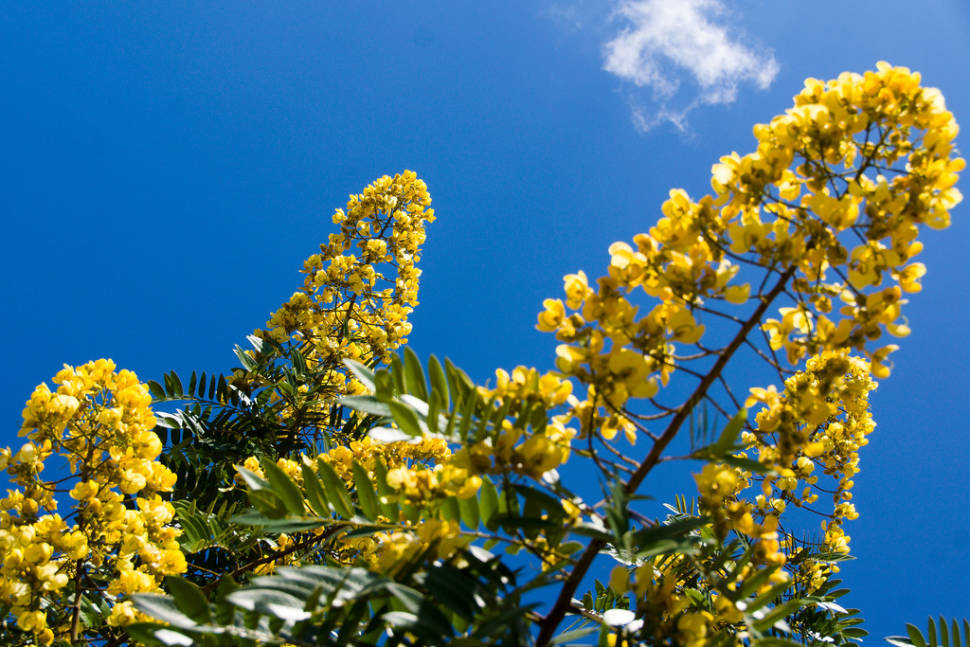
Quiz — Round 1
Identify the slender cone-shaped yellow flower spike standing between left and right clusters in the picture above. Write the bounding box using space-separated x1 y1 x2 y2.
257 171 434 384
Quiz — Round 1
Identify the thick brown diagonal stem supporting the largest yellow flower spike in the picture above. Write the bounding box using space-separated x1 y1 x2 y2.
536 265 796 647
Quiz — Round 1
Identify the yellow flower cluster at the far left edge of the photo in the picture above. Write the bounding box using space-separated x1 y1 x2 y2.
0 359 186 644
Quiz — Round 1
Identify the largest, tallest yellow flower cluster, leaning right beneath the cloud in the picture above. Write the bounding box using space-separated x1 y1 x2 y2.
537 63 965 446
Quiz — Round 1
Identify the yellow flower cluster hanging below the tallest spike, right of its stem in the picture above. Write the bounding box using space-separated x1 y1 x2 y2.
680 350 876 604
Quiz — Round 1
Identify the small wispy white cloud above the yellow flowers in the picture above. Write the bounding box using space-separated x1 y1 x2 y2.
603 0 778 131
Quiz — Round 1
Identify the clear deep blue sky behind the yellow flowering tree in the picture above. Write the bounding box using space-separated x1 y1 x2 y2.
0 0 970 643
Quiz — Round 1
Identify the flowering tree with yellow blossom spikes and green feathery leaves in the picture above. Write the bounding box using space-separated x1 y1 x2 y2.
0 64 967 647
